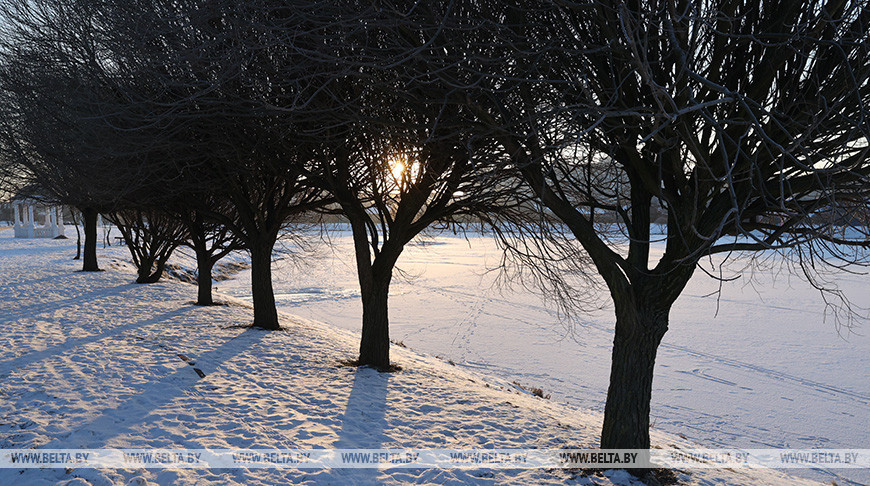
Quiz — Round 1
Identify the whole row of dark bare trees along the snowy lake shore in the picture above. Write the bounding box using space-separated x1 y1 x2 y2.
0 0 870 458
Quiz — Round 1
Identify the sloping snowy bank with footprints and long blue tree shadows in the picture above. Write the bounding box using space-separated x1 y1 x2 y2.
0 230 832 485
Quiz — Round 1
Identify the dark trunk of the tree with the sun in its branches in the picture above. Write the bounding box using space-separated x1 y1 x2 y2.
359 280 391 370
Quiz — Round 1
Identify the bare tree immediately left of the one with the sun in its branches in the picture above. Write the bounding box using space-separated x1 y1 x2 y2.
82 0 334 329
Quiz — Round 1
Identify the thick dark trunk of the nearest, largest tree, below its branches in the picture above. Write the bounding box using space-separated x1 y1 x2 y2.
601 299 670 449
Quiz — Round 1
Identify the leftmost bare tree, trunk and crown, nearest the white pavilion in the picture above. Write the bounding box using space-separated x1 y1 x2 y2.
0 1 166 271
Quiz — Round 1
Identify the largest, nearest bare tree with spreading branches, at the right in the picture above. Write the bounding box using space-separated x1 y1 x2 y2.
470 0 870 456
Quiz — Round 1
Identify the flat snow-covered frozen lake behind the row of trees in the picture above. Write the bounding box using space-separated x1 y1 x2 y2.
218 231 870 484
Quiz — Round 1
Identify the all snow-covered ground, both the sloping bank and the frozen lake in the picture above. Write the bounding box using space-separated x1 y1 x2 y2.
0 230 868 485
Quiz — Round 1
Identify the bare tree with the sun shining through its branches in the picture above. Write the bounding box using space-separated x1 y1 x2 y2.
284 1 515 370
